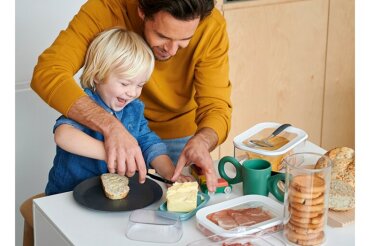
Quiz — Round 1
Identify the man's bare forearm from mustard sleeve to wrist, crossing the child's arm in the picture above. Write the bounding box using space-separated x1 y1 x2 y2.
67 95 123 134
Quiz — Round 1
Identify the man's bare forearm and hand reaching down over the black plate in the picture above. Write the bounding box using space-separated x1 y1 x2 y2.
68 96 146 183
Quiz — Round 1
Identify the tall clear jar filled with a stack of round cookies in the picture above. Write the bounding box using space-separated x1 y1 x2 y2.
283 152 331 245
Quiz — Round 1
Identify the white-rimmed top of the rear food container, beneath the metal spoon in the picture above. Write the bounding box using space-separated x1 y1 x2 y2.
233 122 308 156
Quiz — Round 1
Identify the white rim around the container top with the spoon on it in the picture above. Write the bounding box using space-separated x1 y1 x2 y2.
234 122 308 156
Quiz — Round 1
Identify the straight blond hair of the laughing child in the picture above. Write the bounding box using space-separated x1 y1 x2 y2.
80 28 154 90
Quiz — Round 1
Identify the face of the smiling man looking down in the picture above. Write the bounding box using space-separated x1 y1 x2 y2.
139 10 200 61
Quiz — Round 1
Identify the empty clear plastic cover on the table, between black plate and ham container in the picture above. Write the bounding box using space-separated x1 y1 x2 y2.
126 209 183 243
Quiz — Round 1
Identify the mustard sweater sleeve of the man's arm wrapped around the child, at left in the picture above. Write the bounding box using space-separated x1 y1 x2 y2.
31 0 124 115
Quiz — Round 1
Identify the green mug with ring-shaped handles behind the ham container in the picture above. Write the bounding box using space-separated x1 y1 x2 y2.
218 156 285 202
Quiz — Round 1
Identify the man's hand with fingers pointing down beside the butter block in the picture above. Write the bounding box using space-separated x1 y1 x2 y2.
171 128 218 192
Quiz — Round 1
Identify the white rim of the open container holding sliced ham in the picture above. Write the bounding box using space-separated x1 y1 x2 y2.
196 195 283 238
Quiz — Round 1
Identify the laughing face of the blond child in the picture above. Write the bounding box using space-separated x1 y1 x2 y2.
96 73 146 111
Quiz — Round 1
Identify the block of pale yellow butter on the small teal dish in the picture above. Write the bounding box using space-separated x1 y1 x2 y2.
166 182 198 212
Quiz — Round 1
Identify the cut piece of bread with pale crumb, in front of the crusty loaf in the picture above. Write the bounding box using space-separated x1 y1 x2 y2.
329 179 355 211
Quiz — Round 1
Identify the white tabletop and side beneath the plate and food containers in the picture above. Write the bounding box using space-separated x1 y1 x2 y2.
33 141 355 246
